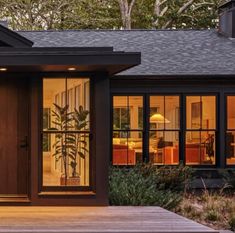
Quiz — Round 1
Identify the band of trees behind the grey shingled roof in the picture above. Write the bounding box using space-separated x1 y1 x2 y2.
0 0 224 30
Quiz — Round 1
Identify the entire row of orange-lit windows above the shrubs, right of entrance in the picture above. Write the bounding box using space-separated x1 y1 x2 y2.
112 93 218 166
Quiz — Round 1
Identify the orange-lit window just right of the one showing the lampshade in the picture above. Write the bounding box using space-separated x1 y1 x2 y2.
185 96 216 165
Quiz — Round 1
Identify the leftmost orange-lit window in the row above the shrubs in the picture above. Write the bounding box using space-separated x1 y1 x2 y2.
113 96 143 165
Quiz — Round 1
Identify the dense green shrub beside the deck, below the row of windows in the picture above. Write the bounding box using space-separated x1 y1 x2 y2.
109 164 193 209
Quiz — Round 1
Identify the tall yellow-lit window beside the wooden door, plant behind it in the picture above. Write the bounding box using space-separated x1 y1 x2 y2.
42 78 90 186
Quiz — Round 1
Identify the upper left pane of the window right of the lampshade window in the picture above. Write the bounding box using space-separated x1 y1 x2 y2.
186 96 202 129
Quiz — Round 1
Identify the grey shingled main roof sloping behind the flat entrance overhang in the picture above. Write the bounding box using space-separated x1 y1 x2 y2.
18 30 235 75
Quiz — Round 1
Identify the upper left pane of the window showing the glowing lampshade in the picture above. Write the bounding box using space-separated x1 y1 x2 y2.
149 96 164 130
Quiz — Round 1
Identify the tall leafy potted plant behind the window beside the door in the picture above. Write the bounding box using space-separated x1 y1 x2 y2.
51 103 89 186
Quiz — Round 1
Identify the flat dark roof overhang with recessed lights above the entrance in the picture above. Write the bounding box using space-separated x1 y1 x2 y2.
0 47 141 75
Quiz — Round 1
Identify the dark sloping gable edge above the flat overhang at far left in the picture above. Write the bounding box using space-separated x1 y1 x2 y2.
0 24 33 48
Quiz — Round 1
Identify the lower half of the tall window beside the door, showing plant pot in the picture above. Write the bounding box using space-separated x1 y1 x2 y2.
43 133 89 186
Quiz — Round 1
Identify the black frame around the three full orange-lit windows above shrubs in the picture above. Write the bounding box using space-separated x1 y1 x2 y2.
110 90 219 169
